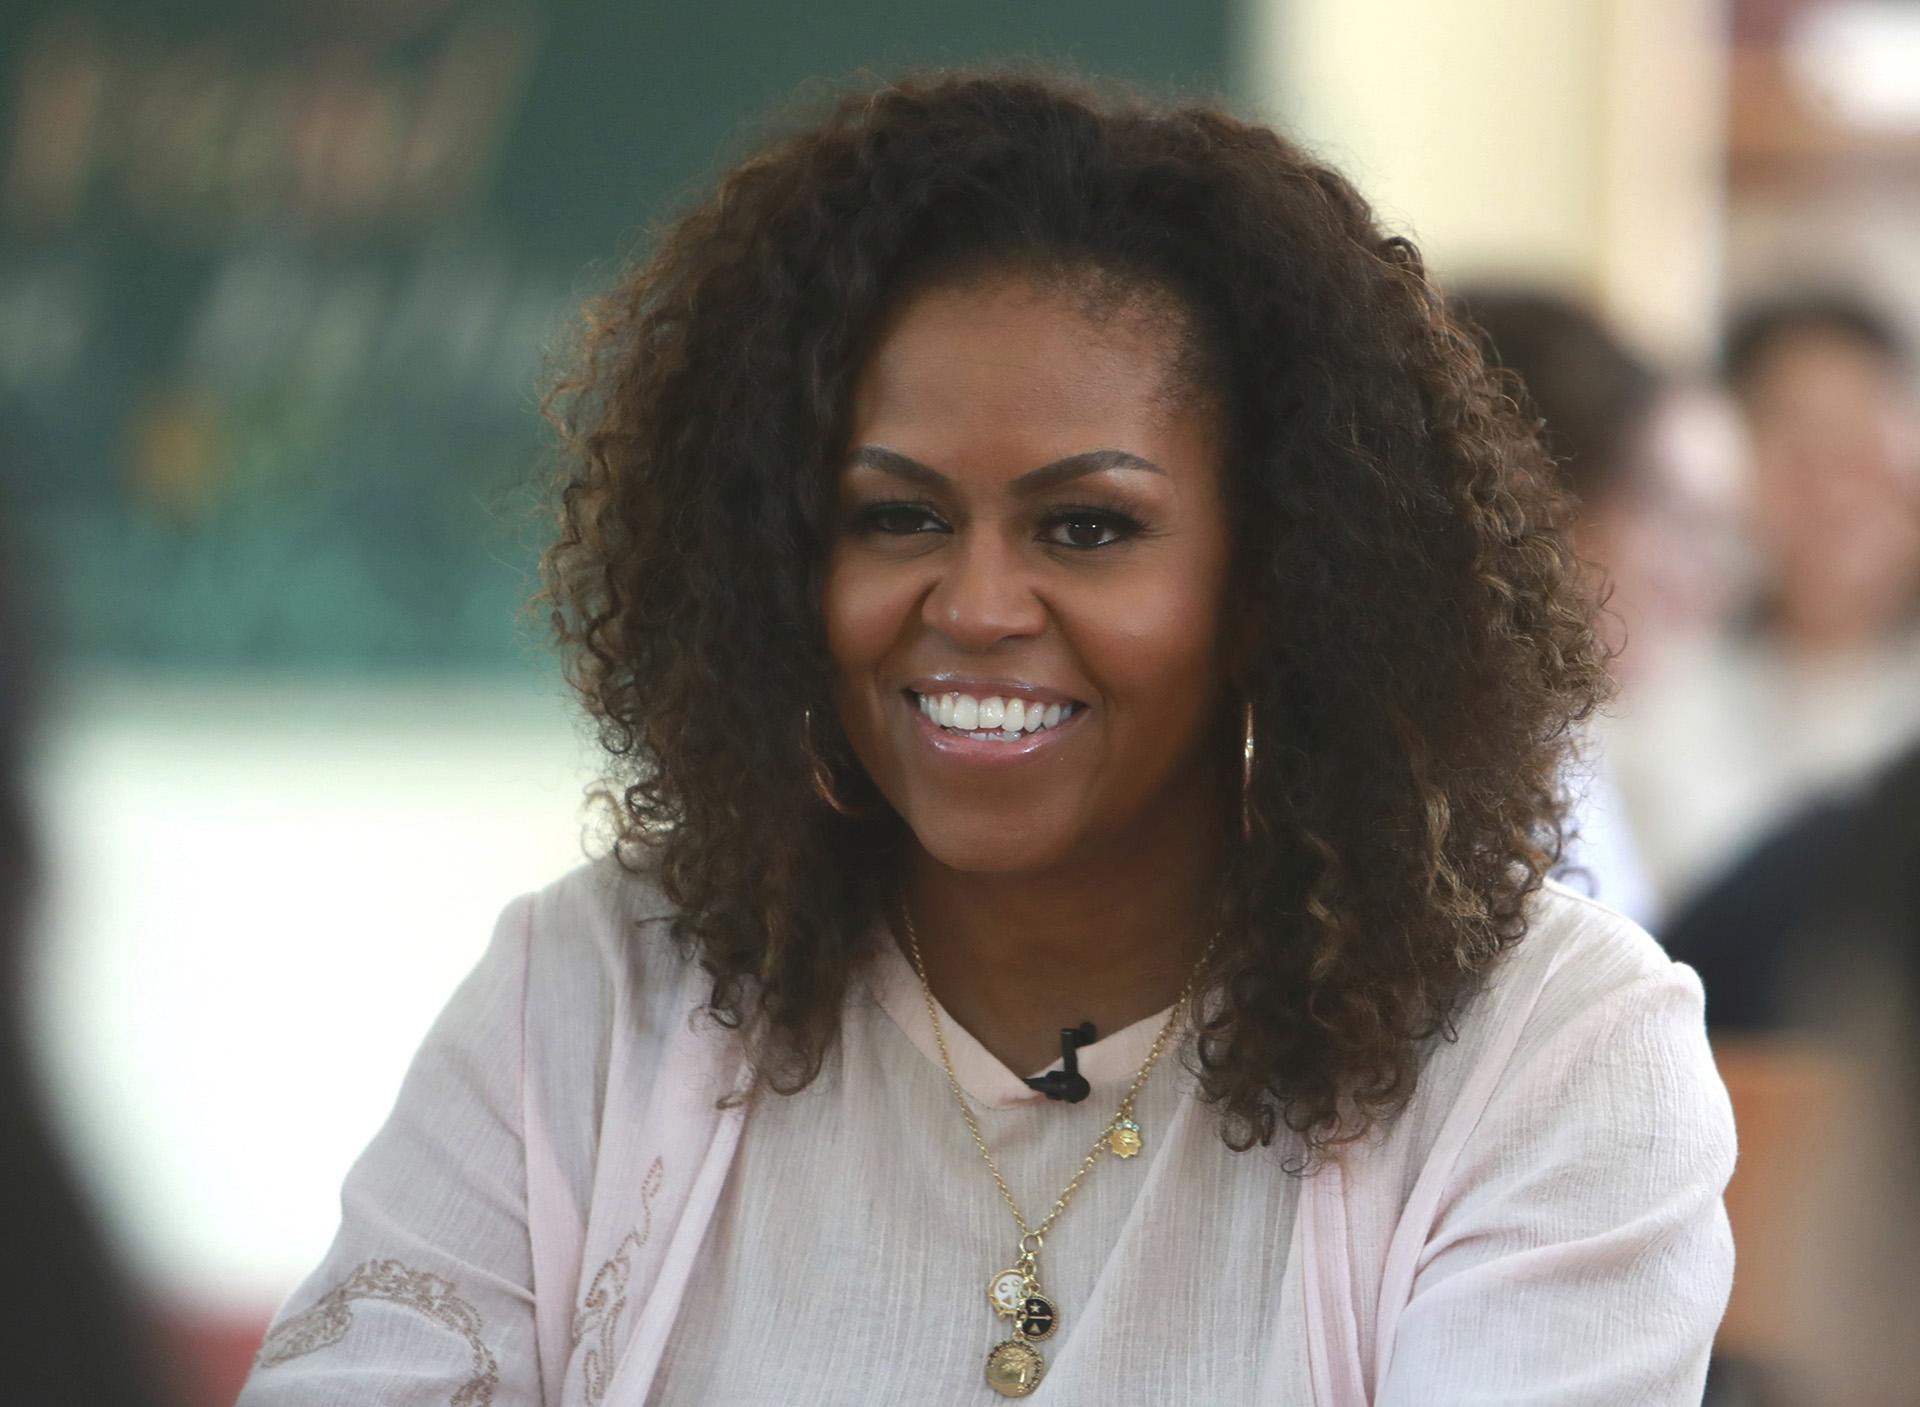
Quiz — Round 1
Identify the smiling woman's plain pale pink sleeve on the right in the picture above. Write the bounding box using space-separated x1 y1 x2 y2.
1375 966 1734 1407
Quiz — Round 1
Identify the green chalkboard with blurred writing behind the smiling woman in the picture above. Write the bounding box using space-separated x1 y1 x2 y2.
0 0 1231 674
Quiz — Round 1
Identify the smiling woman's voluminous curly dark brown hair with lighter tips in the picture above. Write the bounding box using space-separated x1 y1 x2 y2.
540 71 1605 1165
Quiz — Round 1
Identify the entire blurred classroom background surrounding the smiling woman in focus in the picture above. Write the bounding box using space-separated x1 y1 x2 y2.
0 0 1920 1407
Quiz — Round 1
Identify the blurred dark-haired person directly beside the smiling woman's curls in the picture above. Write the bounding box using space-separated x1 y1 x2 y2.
1457 286 1743 929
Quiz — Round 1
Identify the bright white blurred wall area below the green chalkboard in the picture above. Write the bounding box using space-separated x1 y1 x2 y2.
33 678 591 1313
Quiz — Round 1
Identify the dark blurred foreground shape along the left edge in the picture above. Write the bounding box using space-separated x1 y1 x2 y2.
0 487 163 1407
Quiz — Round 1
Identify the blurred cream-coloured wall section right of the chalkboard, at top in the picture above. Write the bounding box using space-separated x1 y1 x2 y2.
1238 0 1726 357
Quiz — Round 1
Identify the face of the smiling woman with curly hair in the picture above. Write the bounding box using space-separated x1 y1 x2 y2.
822 274 1229 873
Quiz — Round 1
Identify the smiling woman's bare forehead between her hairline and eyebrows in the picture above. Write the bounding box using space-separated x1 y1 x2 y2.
851 276 1215 468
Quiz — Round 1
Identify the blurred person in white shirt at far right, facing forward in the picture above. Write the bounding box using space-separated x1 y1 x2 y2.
1613 294 1920 910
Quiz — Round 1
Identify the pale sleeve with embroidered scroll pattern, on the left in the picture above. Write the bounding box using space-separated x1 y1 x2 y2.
238 898 543 1407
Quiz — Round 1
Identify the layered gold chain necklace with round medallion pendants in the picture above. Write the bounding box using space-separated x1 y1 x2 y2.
900 902 1213 1397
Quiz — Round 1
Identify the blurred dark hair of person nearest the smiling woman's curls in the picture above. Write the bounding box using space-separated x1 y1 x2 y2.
1453 288 1661 503
